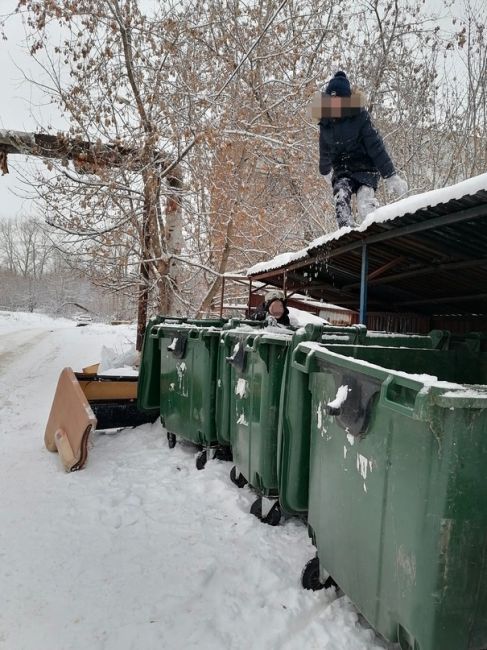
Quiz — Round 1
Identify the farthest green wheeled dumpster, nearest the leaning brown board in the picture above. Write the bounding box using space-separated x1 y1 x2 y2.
150 319 229 469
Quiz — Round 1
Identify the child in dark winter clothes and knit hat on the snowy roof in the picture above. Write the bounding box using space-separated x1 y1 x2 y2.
313 71 408 228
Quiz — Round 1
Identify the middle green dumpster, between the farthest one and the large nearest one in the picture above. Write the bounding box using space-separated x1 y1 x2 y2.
223 328 293 525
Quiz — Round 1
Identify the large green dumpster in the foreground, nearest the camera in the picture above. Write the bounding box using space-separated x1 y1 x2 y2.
293 343 487 650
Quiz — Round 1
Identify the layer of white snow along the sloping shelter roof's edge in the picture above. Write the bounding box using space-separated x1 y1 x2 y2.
247 174 487 275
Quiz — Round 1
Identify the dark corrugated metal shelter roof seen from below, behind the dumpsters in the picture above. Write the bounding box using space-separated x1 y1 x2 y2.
248 185 487 315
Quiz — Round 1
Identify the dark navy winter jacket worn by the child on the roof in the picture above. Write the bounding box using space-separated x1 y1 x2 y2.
319 95 396 189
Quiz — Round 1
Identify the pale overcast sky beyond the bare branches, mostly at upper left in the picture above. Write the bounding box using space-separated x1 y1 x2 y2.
0 0 462 219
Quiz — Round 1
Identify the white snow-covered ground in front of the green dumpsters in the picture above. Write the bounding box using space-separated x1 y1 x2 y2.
0 312 394 650
